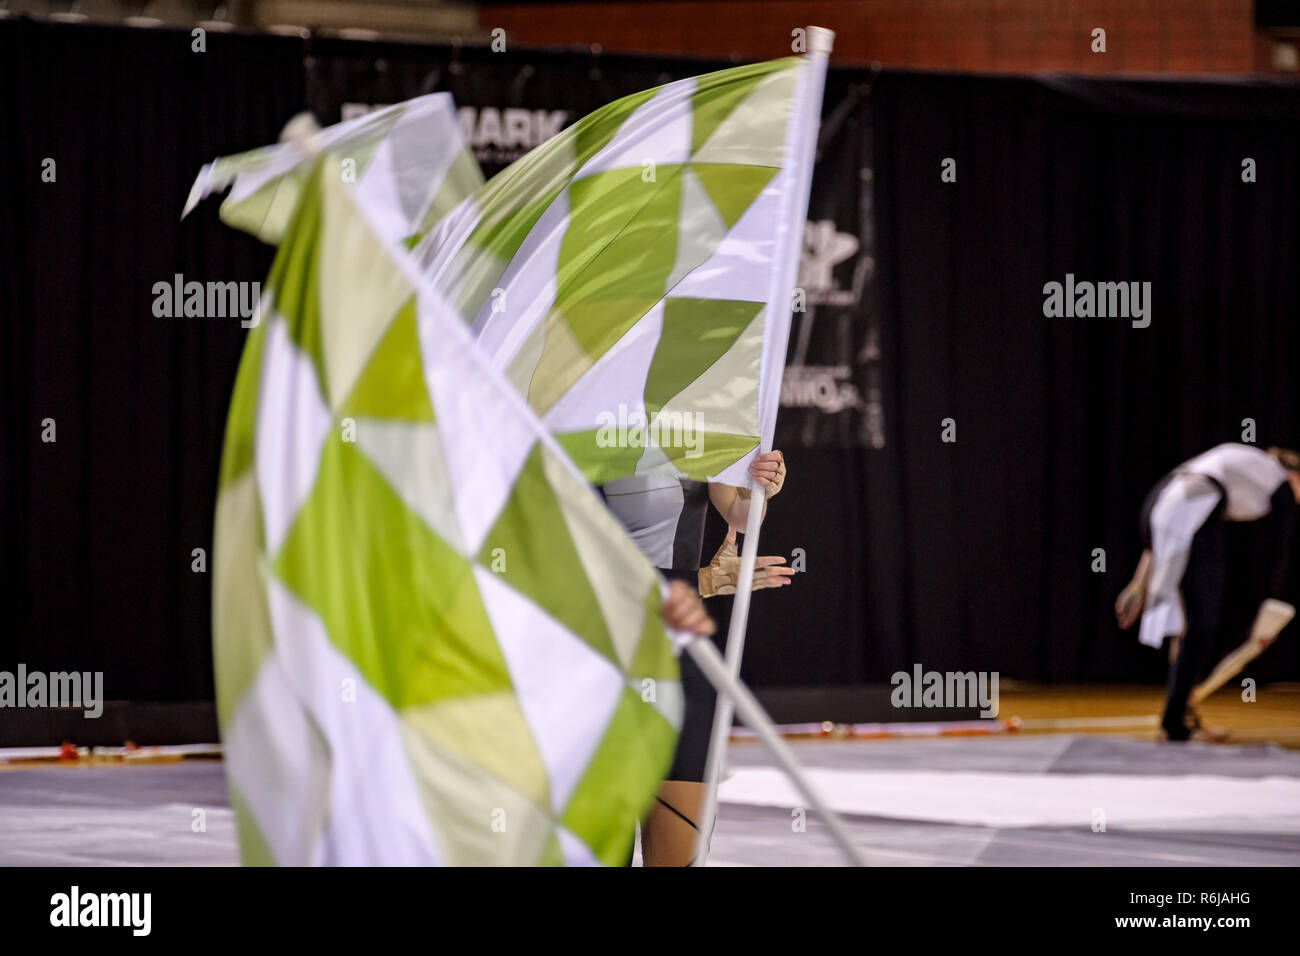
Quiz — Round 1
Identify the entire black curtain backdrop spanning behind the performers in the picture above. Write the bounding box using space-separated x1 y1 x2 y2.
0 21 1300 719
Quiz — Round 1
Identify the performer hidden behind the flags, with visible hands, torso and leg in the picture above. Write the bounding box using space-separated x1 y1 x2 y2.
598 451 794 866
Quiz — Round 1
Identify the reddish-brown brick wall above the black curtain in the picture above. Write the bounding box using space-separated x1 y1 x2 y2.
480 0 1271 73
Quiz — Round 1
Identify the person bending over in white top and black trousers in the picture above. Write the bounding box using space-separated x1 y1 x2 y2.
1115 444 1300 740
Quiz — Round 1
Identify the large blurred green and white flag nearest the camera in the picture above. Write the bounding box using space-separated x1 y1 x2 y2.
213 153 681 865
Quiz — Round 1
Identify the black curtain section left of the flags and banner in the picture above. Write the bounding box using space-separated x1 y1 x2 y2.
0 21 303 700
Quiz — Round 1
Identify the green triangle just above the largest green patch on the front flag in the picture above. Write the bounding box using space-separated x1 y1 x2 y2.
341 295 434 421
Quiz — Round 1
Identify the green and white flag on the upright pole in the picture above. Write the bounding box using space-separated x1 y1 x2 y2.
416 57 826 485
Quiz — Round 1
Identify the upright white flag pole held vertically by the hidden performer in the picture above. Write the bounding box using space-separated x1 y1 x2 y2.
692 26 835 866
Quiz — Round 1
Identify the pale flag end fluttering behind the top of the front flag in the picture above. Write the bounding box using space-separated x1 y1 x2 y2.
181 92 484 245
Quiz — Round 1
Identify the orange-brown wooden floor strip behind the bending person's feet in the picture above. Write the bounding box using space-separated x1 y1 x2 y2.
998 682 1300 749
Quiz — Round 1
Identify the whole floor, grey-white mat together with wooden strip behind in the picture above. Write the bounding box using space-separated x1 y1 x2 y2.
0 682 1300 868
